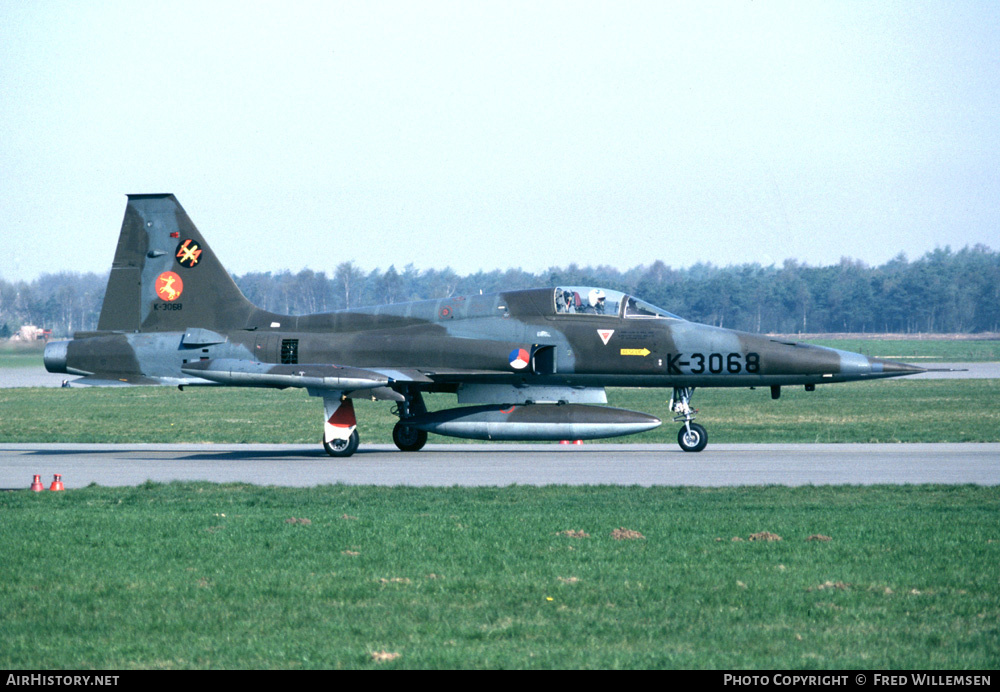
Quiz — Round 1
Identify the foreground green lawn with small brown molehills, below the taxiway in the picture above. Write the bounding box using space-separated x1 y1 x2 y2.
0 483 1000 670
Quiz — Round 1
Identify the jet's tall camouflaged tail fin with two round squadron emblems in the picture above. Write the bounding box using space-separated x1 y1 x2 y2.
97 194 259 331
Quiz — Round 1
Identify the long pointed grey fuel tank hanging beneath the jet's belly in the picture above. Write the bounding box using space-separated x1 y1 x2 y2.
405 404 661 441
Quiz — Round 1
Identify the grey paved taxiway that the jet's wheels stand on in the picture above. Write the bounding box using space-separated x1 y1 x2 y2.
0 443 1000 490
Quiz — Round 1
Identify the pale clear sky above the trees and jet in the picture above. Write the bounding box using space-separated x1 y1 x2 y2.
0 0 1000 280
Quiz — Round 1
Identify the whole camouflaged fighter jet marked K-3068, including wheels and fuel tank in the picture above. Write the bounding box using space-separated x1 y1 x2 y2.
45 194 923 457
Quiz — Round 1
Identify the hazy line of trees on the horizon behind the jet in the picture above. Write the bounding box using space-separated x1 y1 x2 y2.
0 245 1000 337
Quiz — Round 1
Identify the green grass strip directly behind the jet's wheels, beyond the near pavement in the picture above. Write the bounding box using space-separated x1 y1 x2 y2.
0 380 1000 444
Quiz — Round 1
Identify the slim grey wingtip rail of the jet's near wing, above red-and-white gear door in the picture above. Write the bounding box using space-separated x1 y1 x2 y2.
181 358 390 392
